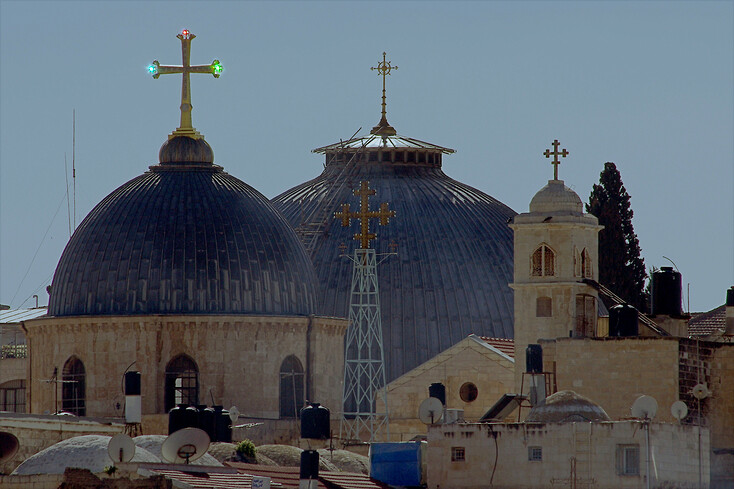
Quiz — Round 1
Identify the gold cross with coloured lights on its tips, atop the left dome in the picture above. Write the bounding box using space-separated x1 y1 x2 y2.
148 29 222 139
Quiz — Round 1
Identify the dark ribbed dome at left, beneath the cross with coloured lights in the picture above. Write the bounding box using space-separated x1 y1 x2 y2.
49 138 317 316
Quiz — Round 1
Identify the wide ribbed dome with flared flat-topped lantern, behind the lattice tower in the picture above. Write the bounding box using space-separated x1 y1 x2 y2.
273 136 515 382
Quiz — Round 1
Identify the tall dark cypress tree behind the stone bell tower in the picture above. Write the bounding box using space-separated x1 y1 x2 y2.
586 163 650 312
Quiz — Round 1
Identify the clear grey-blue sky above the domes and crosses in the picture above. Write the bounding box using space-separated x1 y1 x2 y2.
0 0 734 312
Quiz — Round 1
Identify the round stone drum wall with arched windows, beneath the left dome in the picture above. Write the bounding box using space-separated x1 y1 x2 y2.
25 316 347 422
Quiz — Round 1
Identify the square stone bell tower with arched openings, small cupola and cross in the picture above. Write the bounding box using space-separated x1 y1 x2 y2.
510 140 603 392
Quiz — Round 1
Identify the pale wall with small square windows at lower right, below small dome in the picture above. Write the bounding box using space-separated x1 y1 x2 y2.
427 421 709 489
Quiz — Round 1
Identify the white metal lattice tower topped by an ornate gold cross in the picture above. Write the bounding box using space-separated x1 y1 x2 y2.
334 181 395 443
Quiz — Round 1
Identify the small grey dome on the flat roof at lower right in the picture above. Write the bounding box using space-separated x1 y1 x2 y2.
525 391 611 423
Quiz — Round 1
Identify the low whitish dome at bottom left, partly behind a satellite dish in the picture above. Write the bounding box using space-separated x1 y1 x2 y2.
12 435 160 475
